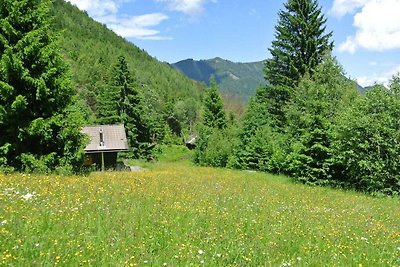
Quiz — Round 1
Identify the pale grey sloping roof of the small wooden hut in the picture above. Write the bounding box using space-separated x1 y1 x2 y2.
82 124 129 153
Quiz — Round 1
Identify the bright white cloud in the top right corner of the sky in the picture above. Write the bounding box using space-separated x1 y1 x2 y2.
332 0 400 53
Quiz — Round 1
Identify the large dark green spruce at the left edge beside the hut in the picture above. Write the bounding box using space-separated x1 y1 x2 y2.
0 0 82 171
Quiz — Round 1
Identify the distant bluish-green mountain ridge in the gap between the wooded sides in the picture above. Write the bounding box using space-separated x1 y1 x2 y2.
172 58 265 101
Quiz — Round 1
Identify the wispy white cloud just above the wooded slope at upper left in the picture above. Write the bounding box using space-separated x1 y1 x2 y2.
67 0 171 40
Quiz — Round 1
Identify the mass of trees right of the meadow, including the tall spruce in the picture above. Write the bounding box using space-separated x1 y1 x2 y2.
195 0 400 195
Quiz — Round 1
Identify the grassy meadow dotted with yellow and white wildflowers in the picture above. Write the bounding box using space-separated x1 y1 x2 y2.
0 155 400 266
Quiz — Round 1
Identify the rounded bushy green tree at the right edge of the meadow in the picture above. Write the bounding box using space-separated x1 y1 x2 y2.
334 77 400 194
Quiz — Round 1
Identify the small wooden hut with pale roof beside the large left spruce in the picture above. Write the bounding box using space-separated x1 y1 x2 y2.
82 124 129 170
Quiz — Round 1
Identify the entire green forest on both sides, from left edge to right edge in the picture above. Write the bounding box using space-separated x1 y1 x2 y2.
0 0 400 195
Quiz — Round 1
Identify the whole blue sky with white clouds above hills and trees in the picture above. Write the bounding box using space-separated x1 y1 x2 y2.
68 0 400 86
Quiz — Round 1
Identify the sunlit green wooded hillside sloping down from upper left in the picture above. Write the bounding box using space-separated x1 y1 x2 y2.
52 0 203 125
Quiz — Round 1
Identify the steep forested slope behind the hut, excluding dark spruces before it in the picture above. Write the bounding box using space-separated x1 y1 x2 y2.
50 0 204 140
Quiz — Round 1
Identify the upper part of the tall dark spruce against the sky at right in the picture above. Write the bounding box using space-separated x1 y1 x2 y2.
265 0 333 87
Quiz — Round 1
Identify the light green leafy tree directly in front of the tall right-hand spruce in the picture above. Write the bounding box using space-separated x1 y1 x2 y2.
286 58 357 184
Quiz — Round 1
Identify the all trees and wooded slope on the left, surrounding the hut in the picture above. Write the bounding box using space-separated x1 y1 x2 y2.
0 0 203 173
